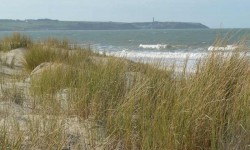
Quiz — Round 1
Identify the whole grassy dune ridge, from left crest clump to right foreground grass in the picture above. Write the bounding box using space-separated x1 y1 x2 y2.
0 33 250 150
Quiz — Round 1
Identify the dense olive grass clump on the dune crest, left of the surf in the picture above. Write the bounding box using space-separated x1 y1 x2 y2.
25 38 94 71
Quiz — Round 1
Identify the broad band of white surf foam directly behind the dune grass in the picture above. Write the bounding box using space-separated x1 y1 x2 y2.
99 49 250 73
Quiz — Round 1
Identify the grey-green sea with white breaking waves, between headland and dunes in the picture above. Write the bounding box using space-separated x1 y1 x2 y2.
0 29 250 71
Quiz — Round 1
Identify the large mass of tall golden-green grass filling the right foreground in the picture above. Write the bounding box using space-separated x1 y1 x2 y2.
29 48 250 149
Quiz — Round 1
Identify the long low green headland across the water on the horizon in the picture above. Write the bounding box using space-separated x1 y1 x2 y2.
0 19 208 31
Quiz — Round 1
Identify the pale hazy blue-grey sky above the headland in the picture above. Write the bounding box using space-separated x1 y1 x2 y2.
0 0 250 28
